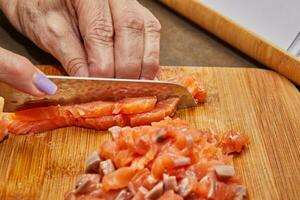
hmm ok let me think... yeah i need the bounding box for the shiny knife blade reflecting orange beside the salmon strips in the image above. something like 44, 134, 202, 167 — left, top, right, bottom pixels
0, 76, 196, 112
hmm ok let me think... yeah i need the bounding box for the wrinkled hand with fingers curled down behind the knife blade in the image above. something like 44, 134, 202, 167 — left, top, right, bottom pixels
0, 0, 161, 79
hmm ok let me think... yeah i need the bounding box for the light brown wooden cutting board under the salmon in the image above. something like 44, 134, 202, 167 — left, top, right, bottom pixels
0, 67, 300, 200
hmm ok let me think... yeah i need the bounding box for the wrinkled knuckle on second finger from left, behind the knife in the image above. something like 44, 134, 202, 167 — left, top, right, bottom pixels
83, 20, 114, 46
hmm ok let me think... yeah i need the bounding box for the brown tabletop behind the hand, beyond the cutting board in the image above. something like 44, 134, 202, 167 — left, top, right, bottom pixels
0, 0, 259, 67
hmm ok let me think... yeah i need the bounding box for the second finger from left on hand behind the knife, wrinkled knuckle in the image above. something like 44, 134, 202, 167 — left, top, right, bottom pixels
74, 0, 115, 78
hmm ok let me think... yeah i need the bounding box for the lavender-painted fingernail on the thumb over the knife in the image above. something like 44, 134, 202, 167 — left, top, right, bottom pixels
33, 72, 57, 95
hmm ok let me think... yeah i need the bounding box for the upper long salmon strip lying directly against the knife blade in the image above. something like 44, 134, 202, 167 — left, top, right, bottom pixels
15, 97, 157, 122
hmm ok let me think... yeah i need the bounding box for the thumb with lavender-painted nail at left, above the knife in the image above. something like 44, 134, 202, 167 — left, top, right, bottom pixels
0, 48, 57, 96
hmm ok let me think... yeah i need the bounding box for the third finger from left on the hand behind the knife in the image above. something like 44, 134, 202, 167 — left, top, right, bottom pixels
110, 0, 144, 79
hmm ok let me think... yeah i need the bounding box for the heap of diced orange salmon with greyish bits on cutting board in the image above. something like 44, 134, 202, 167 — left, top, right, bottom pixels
65, 118, 249, 200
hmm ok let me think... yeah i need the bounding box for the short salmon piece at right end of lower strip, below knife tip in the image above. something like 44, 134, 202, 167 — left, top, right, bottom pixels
128, 98, 179, 126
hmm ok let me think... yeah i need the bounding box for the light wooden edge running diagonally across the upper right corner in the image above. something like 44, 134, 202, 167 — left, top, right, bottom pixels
159, 0, 300, 85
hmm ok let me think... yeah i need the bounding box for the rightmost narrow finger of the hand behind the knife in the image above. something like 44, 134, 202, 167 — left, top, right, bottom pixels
140, 8, 161, 79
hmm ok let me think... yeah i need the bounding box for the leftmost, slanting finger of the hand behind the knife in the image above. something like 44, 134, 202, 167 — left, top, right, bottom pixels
40, 14, 89, 76
